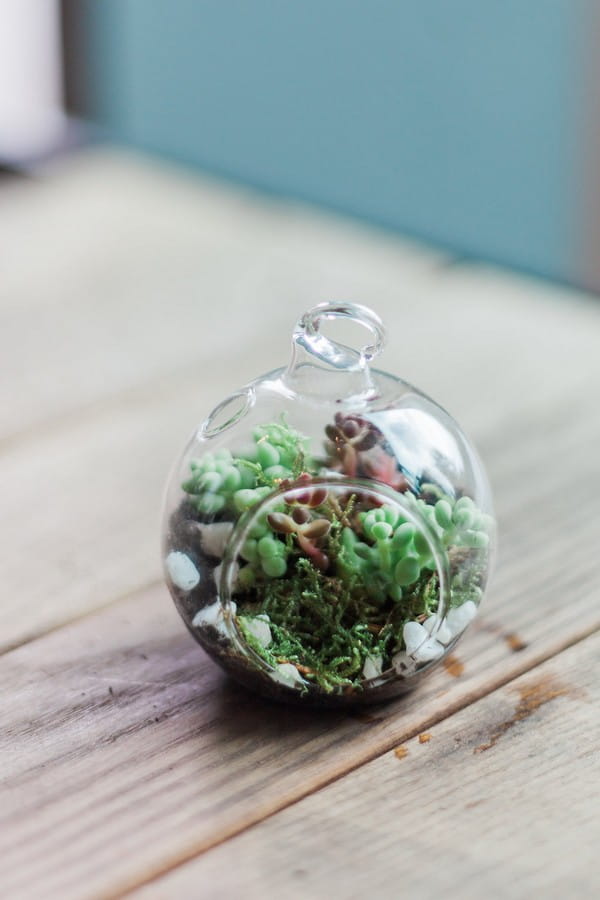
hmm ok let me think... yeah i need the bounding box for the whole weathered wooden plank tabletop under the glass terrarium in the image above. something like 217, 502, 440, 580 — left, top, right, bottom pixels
0, 151, 600, 900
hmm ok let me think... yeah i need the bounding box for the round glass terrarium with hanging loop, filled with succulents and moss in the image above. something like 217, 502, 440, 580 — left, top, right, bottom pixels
163, 303, 495, 705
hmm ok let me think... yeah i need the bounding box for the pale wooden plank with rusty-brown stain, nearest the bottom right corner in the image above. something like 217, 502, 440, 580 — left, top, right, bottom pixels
137, 636, 600, 900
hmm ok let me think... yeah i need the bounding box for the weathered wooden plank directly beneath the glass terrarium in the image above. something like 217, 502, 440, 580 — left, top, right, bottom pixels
0, 418, 600, 898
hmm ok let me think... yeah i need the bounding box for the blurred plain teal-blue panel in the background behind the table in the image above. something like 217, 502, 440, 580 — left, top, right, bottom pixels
86, 0, 588, 280
